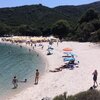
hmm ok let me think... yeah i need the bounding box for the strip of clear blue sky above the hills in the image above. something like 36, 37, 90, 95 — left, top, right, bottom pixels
0, 0, 100, 8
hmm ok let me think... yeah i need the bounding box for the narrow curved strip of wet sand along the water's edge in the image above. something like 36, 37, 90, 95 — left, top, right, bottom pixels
0, 41, 48, 100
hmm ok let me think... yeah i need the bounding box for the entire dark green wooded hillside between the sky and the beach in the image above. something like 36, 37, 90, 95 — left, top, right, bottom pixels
0, 2, 100, 41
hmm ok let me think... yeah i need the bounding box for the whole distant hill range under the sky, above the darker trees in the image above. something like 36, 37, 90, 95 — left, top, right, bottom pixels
0, 2, 100, 26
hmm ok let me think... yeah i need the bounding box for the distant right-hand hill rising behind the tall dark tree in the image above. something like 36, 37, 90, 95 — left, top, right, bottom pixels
54, 1, 100, 24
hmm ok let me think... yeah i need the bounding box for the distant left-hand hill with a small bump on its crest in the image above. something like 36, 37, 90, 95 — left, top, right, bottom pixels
0, 4, 66, 27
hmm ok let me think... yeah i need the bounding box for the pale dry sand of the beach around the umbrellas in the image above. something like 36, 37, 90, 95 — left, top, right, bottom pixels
2, 42, 100, 100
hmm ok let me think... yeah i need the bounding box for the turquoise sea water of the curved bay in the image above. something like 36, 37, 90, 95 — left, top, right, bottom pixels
0, 44, 45, 98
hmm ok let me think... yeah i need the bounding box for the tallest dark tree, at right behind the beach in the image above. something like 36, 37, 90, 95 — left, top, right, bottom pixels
76, 9, 100, 42
